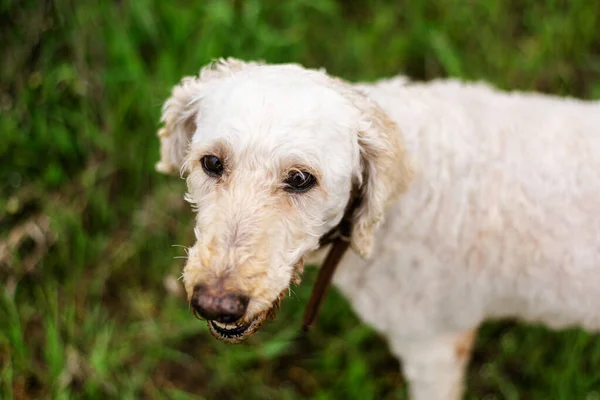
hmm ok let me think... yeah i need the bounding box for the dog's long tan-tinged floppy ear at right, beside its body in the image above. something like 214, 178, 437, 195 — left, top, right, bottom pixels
351, 95, 413, 258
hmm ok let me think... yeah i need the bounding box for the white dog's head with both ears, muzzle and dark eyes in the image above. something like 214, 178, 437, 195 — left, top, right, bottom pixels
157, 59, 410, 342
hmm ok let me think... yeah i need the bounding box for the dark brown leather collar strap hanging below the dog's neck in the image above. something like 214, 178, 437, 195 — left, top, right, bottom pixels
302, 187, 361, 331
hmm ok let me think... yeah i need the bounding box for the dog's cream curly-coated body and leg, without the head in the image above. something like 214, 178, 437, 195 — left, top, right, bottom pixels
328, 77, 600, 399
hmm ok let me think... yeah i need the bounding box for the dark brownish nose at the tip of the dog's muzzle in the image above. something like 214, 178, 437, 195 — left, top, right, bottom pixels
191, 285, 249, 323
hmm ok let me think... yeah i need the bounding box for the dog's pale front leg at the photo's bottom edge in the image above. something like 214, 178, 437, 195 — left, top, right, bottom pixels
390, 329, 476, 400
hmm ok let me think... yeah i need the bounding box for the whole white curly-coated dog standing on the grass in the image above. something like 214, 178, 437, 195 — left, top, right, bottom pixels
157, 59, 600, 399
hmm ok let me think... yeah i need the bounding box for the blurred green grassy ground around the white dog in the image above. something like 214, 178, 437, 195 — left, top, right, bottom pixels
0, 0, 600, 400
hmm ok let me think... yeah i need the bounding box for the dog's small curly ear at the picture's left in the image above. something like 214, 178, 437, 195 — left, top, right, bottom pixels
156, 58, 261, 175
